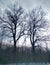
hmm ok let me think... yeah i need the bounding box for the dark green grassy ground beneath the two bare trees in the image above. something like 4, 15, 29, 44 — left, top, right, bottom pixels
0, 47, 50, 64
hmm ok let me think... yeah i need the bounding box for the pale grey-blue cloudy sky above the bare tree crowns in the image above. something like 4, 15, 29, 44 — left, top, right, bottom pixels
0, 0, 50, 20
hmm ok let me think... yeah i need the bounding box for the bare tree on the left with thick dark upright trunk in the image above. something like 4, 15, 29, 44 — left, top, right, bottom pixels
0, 4, 25, 49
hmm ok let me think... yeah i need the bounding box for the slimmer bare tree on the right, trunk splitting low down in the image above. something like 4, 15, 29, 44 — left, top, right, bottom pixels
28, 7, 46, 51
